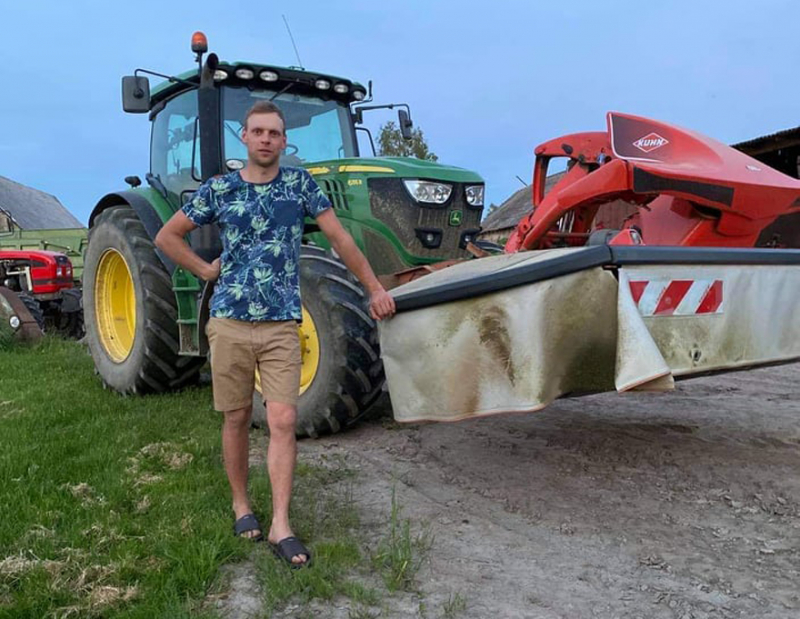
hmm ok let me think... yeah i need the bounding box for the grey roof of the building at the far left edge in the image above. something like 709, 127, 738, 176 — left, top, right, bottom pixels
0, 176, 84, 230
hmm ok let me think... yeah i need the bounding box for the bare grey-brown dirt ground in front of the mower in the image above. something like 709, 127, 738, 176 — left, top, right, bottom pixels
220, 364, 800, 619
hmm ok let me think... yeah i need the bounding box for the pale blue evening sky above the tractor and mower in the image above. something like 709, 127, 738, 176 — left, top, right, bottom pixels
0, 0, 800, 222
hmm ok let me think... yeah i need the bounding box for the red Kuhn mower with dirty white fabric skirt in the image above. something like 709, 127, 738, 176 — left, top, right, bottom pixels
381, 112, 800, 421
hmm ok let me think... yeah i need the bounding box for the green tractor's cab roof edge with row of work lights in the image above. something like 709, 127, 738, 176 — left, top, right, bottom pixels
151, 61, 366, 106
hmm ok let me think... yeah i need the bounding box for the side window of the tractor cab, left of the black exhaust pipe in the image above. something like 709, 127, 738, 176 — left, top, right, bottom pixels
150, 90, 200, 203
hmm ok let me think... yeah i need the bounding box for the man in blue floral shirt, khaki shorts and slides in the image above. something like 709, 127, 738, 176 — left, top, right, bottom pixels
156, 101, 395, 567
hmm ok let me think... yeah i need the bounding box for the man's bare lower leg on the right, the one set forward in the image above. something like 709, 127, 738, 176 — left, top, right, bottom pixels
267, 402, 308, 563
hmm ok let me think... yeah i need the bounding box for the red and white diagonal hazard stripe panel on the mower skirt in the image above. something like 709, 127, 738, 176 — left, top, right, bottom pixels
630, 279, 723, 316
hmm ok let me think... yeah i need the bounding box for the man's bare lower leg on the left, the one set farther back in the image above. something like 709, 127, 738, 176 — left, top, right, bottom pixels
222, 406, 262, 537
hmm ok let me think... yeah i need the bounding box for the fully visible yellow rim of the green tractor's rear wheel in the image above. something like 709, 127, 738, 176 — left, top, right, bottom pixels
94, 249, 136, 363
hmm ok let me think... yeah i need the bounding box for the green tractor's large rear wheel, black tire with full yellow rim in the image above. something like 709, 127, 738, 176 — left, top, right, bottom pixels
83, 204, 205, 394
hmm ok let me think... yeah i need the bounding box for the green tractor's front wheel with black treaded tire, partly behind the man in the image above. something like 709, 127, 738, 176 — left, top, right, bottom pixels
253, 245, 385, 438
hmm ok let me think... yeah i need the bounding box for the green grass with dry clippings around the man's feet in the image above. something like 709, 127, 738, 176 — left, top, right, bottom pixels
0, 338, 418, 619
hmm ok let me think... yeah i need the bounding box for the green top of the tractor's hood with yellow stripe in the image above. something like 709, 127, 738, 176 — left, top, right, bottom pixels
305, 157, 483, 183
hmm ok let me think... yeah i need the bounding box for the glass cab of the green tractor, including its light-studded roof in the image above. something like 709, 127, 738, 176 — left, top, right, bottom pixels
142, 63, 366, 206
